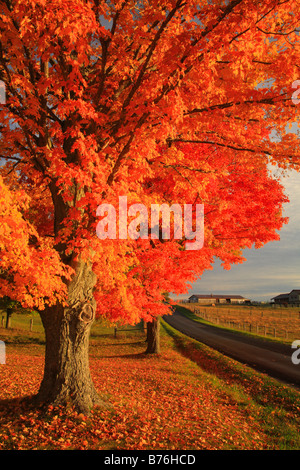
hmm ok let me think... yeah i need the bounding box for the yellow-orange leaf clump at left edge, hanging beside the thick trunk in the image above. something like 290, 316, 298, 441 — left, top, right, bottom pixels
0, 176, 72, 309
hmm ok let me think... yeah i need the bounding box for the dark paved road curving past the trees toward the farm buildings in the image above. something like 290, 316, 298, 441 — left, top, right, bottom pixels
164, 310, 300, 388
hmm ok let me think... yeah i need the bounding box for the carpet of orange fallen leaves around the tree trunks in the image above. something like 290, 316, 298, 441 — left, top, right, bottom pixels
0, 326, 299, 450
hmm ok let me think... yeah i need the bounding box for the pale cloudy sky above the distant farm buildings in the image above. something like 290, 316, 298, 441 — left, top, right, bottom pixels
171, 125, 300, 302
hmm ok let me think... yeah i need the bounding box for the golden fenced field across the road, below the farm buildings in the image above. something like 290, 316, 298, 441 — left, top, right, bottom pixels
184, 303, 300, 342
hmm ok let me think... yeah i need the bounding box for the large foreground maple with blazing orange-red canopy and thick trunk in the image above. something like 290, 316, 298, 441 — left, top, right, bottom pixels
0, 0, 300, 411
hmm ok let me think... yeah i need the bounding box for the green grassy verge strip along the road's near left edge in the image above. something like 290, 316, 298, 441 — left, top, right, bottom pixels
164, 323, 300, 450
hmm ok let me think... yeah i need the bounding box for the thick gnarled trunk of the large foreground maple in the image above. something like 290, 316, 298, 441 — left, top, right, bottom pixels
36, 261, 106, 414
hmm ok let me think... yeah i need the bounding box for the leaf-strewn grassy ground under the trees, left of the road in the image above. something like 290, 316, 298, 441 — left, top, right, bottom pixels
0, 318, 300, 450
